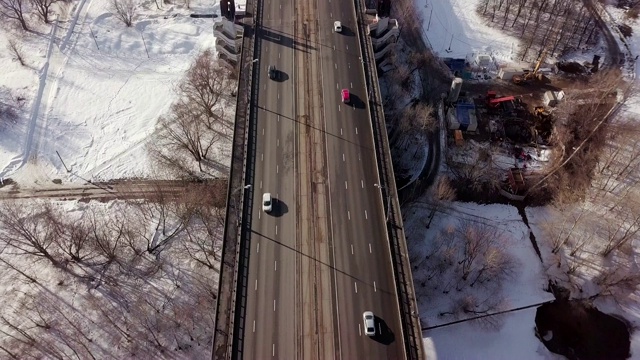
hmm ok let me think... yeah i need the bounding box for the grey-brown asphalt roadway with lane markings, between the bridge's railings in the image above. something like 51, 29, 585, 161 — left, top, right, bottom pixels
242, 0, 405, 359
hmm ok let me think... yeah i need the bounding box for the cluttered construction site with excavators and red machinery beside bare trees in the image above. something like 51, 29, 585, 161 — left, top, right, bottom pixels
441, 50, 622, 200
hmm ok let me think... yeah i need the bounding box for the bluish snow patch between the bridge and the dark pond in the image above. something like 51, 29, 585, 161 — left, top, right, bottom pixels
405, 203, 555, 359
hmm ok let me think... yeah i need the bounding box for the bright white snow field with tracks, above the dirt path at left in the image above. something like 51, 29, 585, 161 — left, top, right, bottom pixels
0, 0, 225, 186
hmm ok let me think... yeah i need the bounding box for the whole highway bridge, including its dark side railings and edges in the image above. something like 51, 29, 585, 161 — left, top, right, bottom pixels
213, 0, 423, 359
